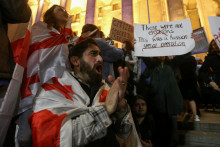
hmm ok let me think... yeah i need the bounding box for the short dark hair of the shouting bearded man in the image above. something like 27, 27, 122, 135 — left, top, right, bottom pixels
69, 38, 98, 68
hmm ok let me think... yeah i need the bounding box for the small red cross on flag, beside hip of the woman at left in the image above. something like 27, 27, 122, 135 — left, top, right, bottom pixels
21, 69, 40, 99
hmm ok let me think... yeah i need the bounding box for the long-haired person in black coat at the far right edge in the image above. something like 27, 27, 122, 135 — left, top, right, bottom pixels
199, 40, 220, 108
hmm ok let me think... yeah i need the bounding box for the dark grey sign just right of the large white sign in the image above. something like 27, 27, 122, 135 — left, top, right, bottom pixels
192, 27, 209, 54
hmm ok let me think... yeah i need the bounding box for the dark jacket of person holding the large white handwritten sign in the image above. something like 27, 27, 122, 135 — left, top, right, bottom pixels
144, 58, 183, 115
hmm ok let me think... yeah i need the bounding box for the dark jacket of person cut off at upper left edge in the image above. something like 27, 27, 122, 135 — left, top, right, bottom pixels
0, 0, 31, 80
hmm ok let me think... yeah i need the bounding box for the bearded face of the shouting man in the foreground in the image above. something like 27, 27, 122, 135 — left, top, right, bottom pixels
80, 45, 103, 84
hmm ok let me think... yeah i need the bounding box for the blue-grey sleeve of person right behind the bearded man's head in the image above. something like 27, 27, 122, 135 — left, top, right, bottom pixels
96, 38, 124, 62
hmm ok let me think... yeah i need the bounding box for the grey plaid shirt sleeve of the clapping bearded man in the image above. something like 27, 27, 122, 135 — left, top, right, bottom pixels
72, 106, 112, 146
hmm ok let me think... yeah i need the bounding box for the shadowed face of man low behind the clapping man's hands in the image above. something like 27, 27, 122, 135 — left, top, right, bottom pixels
133, 99, 147, 117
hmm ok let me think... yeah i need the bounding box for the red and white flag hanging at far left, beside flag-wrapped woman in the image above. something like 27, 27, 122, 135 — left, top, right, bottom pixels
0, 17, 32, 146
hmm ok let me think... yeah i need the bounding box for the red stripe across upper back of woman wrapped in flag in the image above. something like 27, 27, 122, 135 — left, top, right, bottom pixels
28, 32, 67, 57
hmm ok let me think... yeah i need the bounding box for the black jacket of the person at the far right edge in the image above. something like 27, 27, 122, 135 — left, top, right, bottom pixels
199, 53, 220, 86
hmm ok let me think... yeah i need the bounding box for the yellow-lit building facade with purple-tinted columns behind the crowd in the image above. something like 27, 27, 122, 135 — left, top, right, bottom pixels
29, 0, 220, 57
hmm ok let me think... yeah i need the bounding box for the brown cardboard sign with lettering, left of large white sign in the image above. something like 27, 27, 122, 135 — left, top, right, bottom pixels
109, 18, 134, 42
